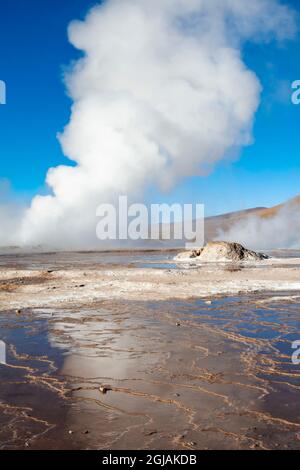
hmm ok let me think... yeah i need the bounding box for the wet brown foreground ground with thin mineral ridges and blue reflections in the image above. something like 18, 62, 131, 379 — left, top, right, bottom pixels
0, 266, 300, 449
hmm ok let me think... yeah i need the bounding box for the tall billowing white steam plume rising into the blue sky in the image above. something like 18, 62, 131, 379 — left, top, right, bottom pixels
0, 0, 295, 247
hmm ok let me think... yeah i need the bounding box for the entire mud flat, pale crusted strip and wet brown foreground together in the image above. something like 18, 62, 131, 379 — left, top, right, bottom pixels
0, 254, 300, 449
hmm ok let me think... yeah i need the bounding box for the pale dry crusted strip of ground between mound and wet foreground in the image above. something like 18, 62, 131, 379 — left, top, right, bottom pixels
0, 253, 300, 309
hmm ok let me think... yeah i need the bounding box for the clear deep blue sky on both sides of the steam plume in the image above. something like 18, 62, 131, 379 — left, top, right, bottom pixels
0, 0, 300, 214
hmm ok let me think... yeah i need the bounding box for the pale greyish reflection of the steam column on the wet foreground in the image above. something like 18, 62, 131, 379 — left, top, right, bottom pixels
44, 306, 184, 448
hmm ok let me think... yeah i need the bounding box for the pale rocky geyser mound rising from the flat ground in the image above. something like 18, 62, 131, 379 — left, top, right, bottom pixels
175, 241, 268, 262
